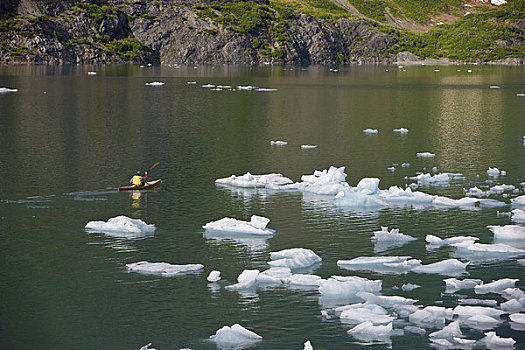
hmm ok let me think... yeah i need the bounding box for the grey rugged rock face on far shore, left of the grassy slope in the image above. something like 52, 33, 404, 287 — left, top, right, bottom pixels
0, 0, 396, 65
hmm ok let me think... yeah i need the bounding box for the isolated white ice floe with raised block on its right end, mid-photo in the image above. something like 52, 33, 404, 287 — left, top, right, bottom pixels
202, 215, 275, 236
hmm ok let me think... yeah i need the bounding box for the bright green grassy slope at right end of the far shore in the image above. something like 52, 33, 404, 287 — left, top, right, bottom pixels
380, 0, 525, 61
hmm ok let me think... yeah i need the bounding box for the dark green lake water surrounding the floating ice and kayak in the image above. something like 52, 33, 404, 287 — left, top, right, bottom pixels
0, 66, 525, 350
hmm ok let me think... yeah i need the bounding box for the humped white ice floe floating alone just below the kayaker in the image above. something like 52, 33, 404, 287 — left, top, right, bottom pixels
85, 215, 155, 238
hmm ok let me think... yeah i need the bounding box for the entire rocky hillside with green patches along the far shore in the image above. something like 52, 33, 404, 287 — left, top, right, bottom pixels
0, 0, 525, 65
